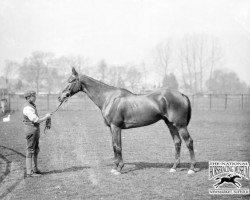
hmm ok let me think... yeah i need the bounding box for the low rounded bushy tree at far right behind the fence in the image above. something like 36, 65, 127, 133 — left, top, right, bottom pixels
206, 70, 247, 94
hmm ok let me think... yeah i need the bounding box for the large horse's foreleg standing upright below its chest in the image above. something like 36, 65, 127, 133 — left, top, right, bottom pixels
111, 124, 124, 174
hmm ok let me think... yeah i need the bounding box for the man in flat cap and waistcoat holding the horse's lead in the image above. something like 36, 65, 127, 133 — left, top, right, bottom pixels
23, 90, 51, 177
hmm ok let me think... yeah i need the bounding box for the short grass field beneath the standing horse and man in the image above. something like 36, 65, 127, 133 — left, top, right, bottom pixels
0, 110, 250, 199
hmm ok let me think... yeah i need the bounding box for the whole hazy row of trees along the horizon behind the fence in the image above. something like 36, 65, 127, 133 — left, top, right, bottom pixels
0, 34, 250, 94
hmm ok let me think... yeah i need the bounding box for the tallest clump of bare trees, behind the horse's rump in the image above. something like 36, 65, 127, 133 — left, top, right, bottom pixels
179, 34, 222, 93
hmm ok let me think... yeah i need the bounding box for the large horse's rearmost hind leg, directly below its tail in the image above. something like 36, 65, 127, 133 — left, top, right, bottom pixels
178, 127, 196, 174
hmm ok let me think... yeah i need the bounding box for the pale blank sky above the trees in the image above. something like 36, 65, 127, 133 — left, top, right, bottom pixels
0, 0, 250, 85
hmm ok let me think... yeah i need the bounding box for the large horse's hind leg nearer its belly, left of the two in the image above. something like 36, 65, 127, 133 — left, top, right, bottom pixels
164, 119, 181, 172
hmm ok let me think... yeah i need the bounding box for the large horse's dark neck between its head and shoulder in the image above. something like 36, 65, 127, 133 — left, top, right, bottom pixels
82, 76, 114, 109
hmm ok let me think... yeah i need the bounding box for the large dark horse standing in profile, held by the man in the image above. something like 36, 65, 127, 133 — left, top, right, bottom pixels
58, 68, 195, 175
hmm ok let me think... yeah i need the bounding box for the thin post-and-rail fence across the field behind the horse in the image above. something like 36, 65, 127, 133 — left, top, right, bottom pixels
2, 93, 250, 111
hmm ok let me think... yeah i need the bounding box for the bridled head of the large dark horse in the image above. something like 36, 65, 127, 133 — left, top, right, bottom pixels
58, 67, 82, 102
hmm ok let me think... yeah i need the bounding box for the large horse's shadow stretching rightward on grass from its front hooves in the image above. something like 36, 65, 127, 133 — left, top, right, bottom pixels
123, 162, 208, 174
